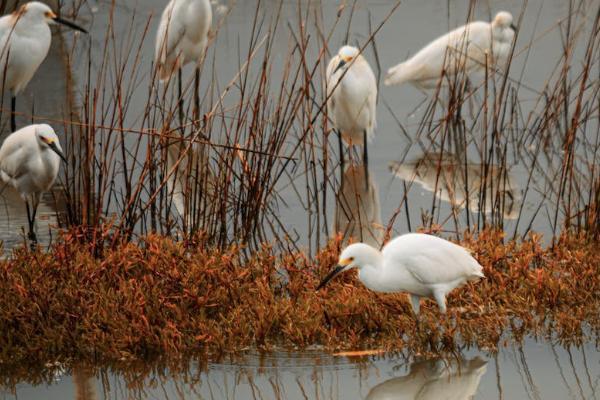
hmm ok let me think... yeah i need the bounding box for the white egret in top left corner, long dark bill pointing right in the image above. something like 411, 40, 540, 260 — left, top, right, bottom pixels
0, 1, 87, 132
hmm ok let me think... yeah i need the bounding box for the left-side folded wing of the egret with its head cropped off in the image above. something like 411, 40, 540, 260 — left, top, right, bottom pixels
155, 0, 185, 79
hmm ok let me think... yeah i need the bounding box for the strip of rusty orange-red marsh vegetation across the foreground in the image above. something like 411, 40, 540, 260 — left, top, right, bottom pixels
0, 231, 600, 366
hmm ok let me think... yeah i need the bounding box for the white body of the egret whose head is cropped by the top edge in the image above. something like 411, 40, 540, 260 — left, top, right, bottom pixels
155, 0, 212, 80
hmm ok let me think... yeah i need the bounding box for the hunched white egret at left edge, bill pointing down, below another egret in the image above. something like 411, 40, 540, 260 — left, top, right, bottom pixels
0, 124, 67, 242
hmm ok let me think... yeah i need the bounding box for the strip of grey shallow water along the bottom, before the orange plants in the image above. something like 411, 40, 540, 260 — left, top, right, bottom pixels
0, 341, 600, 400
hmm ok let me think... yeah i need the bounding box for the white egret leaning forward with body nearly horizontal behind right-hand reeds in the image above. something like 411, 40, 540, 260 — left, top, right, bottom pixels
384, 11, 516, 89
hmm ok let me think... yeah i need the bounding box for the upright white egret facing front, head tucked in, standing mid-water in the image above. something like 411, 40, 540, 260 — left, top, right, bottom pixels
326, 46, 377, 171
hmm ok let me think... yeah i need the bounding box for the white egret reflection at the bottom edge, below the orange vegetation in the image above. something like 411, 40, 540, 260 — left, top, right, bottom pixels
367, 357, 487, 400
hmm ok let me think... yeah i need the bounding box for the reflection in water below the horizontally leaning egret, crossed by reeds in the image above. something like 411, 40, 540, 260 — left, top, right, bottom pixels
390, 153, 522, 219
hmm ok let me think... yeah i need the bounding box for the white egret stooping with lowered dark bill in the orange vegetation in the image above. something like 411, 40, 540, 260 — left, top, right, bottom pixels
317, 233, 484, 315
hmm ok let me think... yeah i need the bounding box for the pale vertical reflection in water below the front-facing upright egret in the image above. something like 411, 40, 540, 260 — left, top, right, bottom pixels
333, 165, 384, 247
